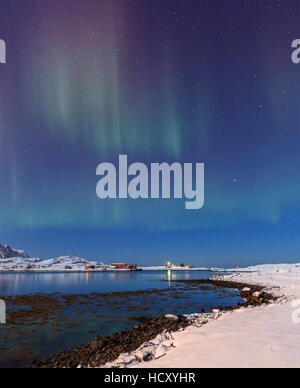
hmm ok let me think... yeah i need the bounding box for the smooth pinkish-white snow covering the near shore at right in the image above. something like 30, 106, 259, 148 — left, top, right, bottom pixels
133, 264, 300, 368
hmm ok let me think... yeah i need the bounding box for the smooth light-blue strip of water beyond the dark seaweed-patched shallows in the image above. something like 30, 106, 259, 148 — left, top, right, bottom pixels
0, 271, 204, 296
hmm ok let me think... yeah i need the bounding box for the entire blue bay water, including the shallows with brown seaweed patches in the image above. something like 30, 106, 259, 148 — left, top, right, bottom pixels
0, 271, 242, 367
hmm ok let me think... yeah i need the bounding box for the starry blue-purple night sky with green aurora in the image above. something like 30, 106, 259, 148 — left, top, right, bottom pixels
0, 0, 300, 266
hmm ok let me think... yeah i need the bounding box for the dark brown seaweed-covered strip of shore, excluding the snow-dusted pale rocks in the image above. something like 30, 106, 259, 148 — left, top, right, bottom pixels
33, 280, 277, 368
